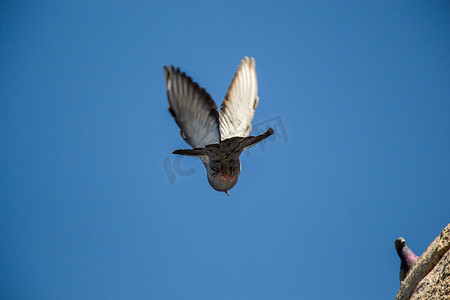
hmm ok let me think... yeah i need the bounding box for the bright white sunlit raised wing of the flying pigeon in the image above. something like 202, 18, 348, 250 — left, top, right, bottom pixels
219, 57, 259, 140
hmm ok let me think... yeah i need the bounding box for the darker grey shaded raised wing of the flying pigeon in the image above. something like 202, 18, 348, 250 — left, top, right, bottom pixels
164, 66, 220, 148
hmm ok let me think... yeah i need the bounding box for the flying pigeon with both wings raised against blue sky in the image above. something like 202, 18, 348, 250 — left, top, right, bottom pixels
164, 57, 273, 195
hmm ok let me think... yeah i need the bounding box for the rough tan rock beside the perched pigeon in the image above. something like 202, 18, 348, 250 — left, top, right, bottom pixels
395, 224, 450, 300
